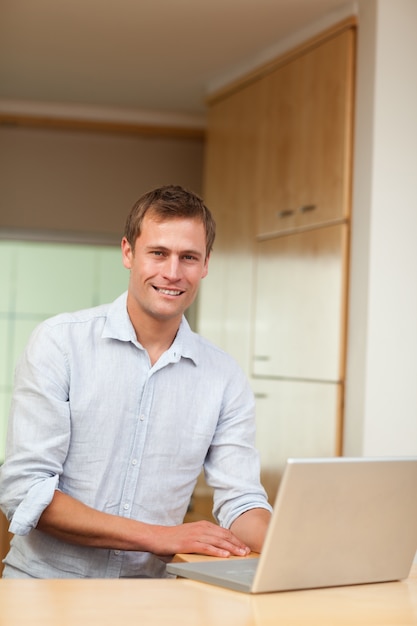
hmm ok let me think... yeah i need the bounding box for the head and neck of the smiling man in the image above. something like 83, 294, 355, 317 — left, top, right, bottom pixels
122, 192, 210, 363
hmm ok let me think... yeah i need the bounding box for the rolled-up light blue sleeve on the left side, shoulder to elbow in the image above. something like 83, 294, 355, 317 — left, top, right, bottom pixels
0, 324, 70, 535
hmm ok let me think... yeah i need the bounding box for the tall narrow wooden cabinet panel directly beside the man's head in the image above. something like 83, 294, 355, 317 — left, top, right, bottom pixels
197, 80, 260, 373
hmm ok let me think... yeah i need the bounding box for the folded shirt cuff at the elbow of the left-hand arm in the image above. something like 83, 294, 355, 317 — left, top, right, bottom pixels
9, 475, 59, 535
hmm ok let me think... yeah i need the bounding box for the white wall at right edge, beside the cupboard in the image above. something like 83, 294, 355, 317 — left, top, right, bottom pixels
344, 0, 417, 455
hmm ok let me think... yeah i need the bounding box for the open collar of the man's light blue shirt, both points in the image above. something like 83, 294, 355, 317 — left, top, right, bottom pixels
102, 291, 199, 365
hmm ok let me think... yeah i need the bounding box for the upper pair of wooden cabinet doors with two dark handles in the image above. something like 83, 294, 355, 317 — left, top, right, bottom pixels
256, 29, 355, 235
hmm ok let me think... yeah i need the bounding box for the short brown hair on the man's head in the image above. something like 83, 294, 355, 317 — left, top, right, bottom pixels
124, 185, 216, 257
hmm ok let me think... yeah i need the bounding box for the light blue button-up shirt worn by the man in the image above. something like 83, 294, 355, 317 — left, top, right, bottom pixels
0, 294, 271, 578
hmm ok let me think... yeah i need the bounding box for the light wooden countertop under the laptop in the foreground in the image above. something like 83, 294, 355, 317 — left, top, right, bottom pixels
0, 565, 417, 626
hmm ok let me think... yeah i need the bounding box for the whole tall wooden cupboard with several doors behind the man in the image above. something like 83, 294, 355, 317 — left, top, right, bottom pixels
197, 18, 355, 500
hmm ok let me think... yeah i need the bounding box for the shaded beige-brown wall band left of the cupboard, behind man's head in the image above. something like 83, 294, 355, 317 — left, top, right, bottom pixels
0, 126, 204, 242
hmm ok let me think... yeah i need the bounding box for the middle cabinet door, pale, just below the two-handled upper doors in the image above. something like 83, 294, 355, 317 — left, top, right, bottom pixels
253, 224, 348, 382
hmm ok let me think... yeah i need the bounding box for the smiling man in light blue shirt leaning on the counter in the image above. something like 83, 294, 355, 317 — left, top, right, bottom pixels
0, 186, 271, 578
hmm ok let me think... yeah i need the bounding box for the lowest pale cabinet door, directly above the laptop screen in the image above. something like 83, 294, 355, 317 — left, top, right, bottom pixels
252, 379, 342, 500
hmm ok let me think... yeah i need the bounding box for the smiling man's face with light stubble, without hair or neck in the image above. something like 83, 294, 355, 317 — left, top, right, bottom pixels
122, 214, 208, 321
